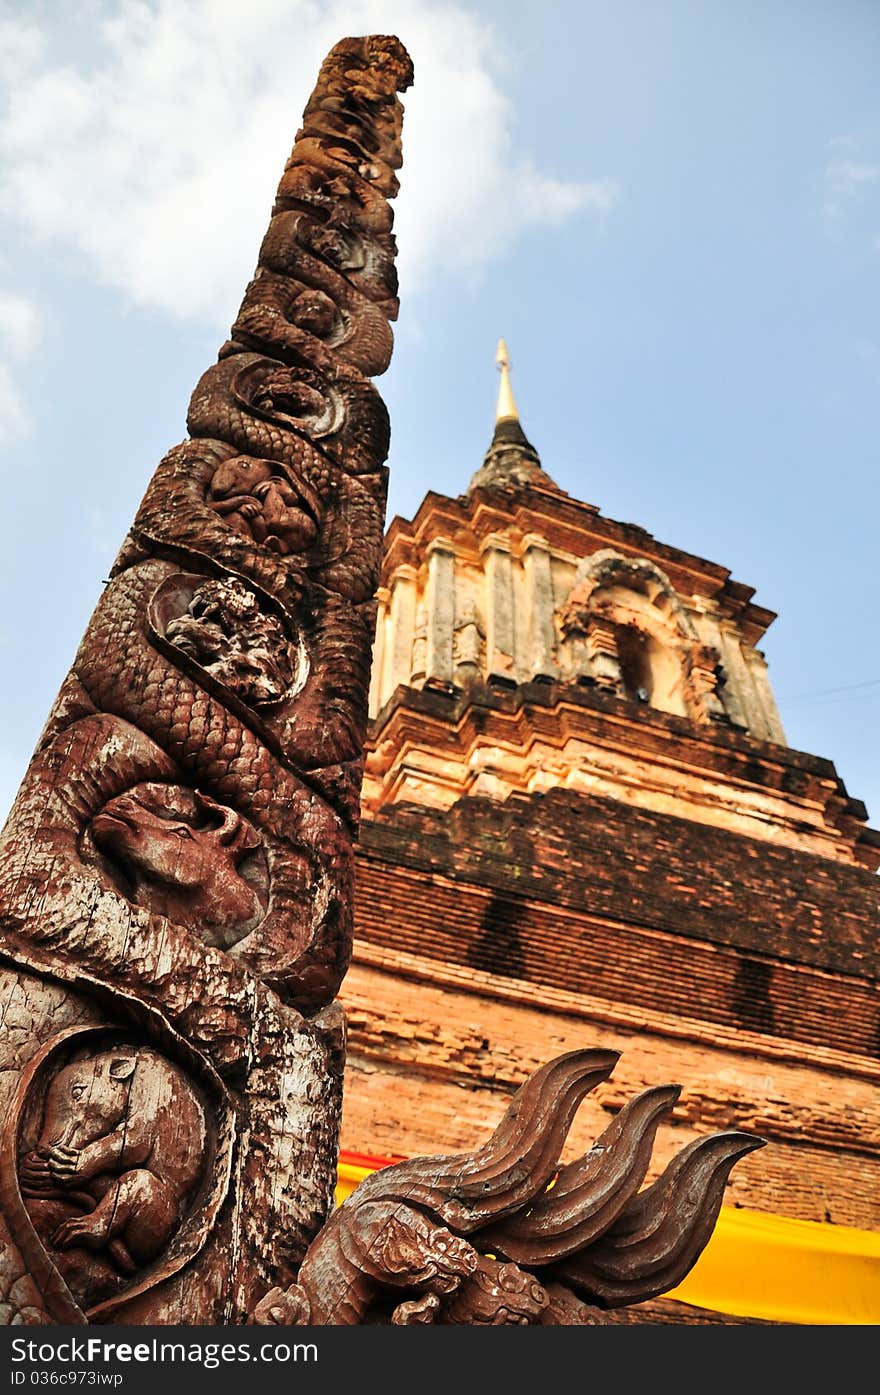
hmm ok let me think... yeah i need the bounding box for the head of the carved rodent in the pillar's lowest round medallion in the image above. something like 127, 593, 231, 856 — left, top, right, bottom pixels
39, 1050, 137, 1148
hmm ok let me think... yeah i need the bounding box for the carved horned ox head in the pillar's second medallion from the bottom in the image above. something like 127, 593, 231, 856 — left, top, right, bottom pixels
92, 784, 265, 947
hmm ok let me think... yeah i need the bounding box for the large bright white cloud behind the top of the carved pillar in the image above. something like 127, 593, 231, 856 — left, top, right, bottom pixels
0, 0, 618, 326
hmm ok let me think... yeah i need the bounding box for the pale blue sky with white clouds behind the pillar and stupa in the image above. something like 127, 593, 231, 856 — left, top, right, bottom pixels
0, 0, 880, 823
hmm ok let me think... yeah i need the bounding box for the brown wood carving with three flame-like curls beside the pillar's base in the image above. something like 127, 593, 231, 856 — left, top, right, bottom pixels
252, 1050, 763, 1327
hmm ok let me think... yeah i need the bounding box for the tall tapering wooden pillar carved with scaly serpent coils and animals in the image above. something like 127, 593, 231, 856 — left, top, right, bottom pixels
0, 36, 411, 1324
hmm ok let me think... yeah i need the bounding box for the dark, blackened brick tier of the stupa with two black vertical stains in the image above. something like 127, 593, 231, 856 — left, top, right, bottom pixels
356, 790, 880, 1056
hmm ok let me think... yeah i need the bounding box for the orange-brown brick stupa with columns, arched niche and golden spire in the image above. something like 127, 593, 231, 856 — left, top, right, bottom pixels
342, 343, 880, 1322
